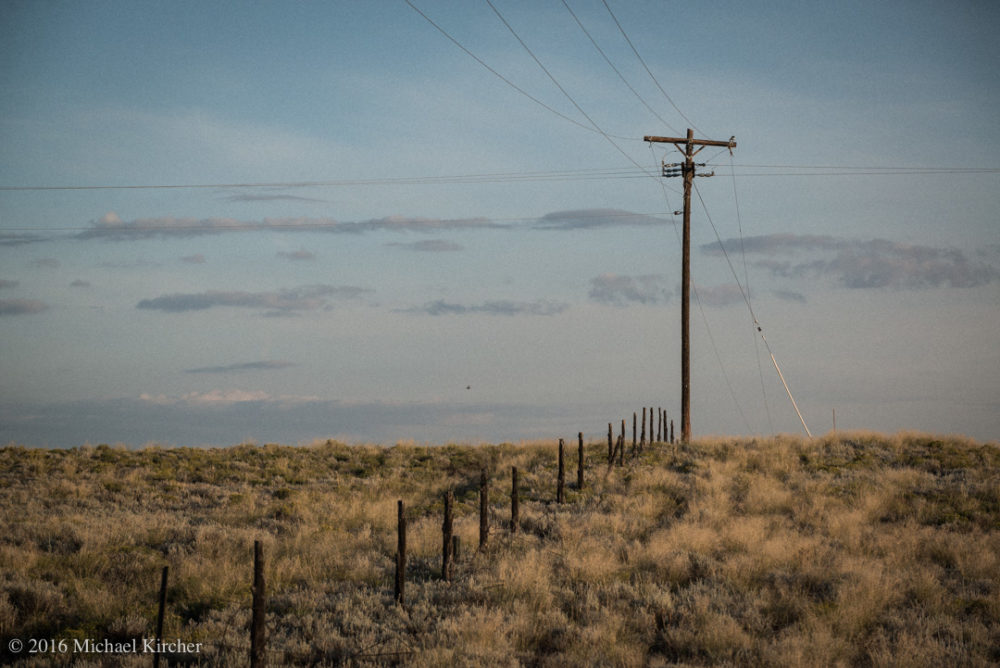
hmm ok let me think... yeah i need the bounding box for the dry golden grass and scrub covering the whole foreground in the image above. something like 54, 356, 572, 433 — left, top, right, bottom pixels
0, 433, 1000, 666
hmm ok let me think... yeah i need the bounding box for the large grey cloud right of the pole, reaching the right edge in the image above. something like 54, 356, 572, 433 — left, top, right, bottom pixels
701, 234, 1000, 289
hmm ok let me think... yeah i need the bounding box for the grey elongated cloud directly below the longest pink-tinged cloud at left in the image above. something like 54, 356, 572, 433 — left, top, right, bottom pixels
136, 285, 374, 314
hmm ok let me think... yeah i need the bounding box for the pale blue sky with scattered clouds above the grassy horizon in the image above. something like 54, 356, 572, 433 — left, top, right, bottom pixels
0, 0, 1000, 447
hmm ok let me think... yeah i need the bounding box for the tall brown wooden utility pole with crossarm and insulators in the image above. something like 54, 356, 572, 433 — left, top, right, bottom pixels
643, 128, 736, 443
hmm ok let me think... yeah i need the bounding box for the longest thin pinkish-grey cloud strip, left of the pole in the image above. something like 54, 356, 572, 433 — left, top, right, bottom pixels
74, 212, 507, 241
